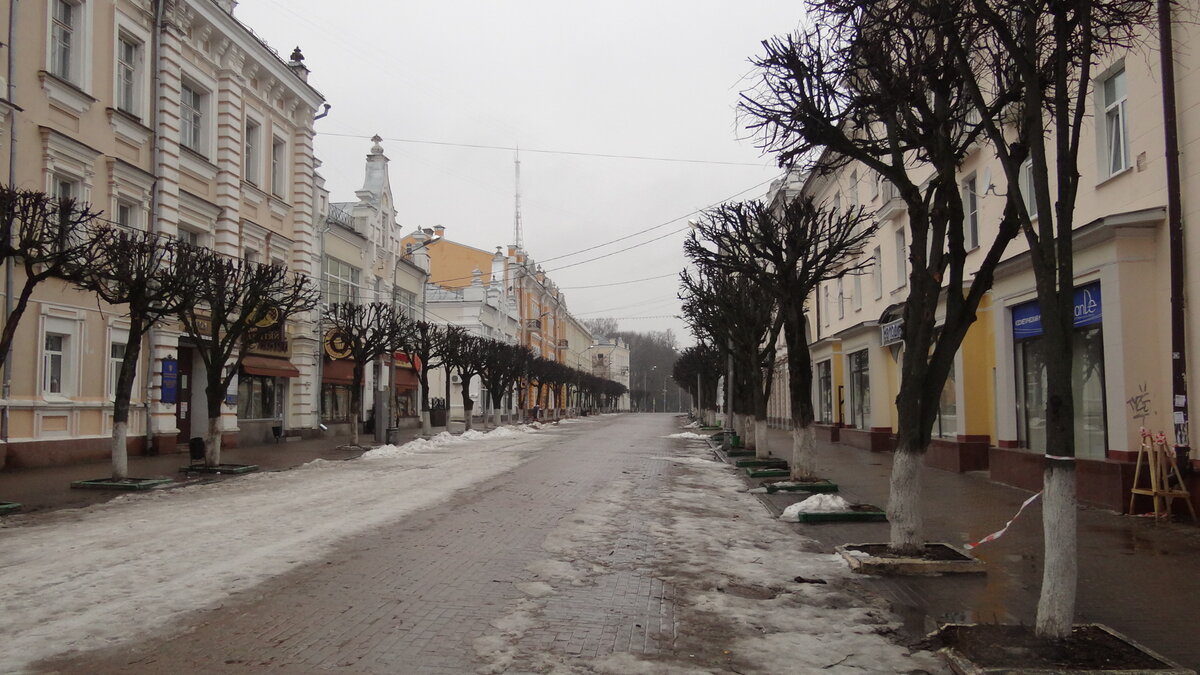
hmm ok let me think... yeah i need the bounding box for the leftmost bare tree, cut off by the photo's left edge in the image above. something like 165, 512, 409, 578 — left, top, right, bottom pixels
0, 186, 98, 369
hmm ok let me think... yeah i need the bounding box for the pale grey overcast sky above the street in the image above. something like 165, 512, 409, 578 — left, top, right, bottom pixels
235, 0, 802, 345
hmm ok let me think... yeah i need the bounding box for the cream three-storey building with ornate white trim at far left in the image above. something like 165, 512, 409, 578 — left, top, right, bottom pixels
0, 0, 323, 466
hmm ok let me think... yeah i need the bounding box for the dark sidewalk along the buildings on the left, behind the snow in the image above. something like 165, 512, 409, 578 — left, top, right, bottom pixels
0, 423, 439, 513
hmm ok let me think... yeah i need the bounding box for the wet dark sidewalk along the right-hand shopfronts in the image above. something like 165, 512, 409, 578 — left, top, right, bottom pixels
750, 429, 1200, 668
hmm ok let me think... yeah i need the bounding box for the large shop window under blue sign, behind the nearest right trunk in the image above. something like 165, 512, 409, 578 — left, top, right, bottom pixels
1013, 283, 1108, 459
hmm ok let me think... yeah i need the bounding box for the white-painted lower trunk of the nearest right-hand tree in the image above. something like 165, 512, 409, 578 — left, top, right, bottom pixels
1037, 461, 1079, 638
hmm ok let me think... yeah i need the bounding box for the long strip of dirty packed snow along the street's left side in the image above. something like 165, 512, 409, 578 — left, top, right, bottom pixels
0, 428, 548, 673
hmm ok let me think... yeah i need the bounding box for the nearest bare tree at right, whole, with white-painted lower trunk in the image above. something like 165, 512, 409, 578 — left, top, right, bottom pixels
953, 0, 1156, 638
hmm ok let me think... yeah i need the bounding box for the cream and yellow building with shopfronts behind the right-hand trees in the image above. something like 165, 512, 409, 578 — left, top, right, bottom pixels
769, 12, 1200, 510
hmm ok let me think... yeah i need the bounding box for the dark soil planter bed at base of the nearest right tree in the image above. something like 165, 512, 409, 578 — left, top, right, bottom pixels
925, 623, 1195, 675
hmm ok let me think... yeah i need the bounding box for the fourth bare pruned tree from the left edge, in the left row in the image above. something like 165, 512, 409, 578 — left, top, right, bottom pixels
324, 303, 413, 446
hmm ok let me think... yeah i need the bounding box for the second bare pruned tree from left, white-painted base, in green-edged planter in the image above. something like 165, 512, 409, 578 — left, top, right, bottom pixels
76, 227, 200, 479
